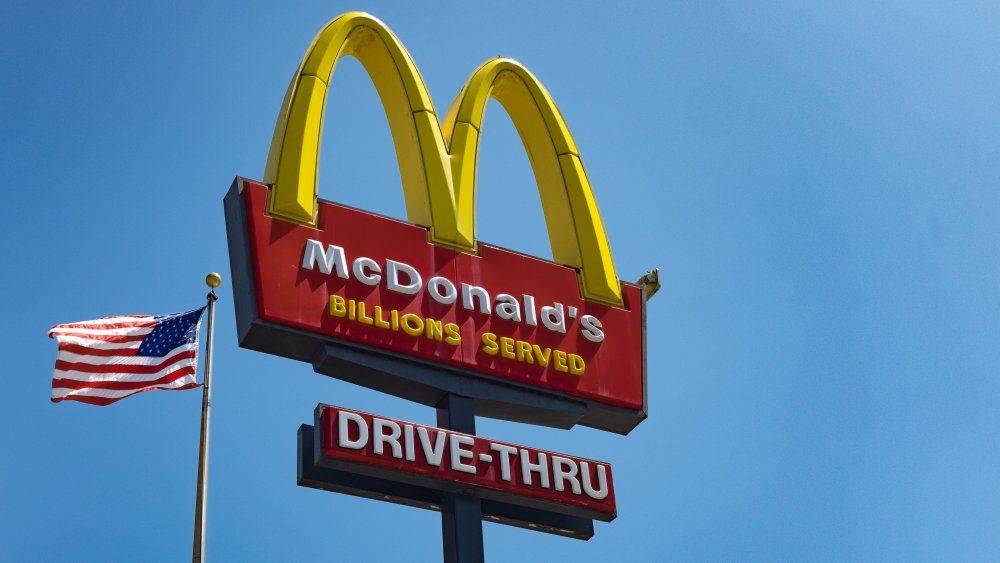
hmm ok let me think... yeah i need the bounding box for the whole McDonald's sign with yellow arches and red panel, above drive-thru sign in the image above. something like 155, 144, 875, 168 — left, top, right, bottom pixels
225, 13, 647, 433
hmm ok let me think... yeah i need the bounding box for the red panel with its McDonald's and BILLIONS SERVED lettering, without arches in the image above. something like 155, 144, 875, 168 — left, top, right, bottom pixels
241, 180, 644, 411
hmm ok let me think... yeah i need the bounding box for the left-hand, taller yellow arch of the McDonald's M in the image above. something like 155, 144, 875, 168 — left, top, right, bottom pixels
264, 12, 466, 248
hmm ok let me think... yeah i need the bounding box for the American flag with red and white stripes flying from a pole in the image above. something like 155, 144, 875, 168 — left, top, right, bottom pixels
49, 307, 205, 405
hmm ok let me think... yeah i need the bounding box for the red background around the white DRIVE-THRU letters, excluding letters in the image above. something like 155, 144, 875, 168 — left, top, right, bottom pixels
317, 405, 617, 521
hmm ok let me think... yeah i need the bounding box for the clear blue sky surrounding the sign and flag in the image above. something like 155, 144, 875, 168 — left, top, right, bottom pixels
0, 1, 1000, 561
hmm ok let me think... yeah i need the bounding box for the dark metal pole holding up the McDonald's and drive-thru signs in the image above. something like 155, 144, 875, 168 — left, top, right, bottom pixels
437, 393, 485, 563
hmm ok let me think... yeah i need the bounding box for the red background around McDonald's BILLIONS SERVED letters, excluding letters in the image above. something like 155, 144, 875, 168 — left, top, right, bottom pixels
242, 181, 643, 410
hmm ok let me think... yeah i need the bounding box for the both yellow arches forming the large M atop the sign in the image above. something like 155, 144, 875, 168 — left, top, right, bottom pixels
264, 12, 622, 306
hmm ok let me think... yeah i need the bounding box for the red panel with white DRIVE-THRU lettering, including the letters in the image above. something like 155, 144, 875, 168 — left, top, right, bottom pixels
316, 405, 616, 522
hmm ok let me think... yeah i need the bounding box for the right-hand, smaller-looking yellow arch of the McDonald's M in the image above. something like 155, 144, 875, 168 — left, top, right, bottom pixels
444, 57, 622, 305
